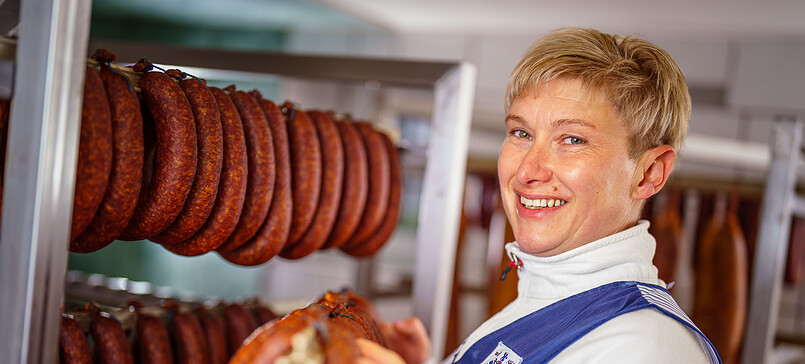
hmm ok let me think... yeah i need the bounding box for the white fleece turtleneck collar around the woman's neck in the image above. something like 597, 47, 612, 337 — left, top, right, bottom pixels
506, 220, 665, 300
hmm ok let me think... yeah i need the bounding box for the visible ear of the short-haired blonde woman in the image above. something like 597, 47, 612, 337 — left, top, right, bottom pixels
632, 145, 676, 200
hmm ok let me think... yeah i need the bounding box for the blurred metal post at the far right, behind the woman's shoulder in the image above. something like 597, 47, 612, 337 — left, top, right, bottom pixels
741, 117, 803, 364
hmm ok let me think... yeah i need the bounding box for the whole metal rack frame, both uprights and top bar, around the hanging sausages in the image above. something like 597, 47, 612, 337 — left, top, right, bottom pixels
0, 0, 476, 363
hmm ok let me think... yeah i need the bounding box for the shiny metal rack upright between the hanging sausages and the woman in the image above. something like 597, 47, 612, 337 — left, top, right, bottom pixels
414, 63, 476, 363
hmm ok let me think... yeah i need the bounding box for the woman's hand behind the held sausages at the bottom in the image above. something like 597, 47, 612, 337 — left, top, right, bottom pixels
358, 317, 430, 364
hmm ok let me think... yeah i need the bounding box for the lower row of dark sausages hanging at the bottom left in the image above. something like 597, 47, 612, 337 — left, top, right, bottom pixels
59, 302, 277, 364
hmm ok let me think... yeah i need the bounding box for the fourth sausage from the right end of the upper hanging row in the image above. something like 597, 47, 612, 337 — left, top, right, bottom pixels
280, 110, 344, 259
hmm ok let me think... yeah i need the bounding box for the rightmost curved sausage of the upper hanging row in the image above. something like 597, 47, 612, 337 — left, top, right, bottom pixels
344, 133, 402, 257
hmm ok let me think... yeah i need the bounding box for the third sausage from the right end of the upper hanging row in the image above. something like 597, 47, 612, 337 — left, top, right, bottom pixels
323, 121, 369, 249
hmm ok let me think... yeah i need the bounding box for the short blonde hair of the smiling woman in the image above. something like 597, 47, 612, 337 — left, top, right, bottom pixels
506, 28, 691, 158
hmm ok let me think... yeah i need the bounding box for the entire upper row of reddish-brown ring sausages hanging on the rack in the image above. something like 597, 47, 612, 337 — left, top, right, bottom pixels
70, 51, 402, 265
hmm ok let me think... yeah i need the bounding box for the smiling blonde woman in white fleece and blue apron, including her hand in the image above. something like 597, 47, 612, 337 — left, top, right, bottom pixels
361, 28, 720, 363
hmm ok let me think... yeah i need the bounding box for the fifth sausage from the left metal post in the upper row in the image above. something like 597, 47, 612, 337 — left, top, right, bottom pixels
166, 87, 249, 252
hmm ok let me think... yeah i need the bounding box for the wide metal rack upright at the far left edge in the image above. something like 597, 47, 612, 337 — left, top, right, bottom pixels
0, 0, 92, 363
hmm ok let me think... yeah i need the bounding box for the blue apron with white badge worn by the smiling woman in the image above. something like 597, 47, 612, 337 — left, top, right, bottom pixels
452, 282, 721, 364
